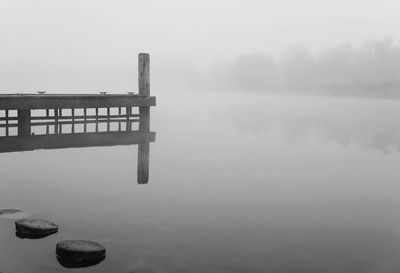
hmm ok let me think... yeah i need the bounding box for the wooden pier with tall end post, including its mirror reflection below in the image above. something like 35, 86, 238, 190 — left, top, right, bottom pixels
0, 53, 156, 184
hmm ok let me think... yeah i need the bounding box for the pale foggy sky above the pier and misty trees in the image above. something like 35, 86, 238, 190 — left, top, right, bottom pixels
0, 0, 400, 92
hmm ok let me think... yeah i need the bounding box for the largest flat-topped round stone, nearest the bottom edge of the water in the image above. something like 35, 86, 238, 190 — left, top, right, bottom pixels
56, 240, 106, 262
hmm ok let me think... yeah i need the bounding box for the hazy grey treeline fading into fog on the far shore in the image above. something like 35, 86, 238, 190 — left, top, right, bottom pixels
177, 39, 400, 97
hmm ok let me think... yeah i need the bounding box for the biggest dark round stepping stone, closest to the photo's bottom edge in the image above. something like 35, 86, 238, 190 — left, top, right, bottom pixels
56, 240, 106, 268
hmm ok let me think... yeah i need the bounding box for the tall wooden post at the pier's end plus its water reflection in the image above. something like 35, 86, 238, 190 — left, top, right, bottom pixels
137, 53, 150, 184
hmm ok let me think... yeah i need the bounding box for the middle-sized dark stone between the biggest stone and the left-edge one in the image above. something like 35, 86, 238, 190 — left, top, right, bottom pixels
15, 219, 58, 239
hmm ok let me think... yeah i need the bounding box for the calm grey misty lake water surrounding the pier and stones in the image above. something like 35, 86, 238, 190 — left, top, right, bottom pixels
0, 92, 400, 273
